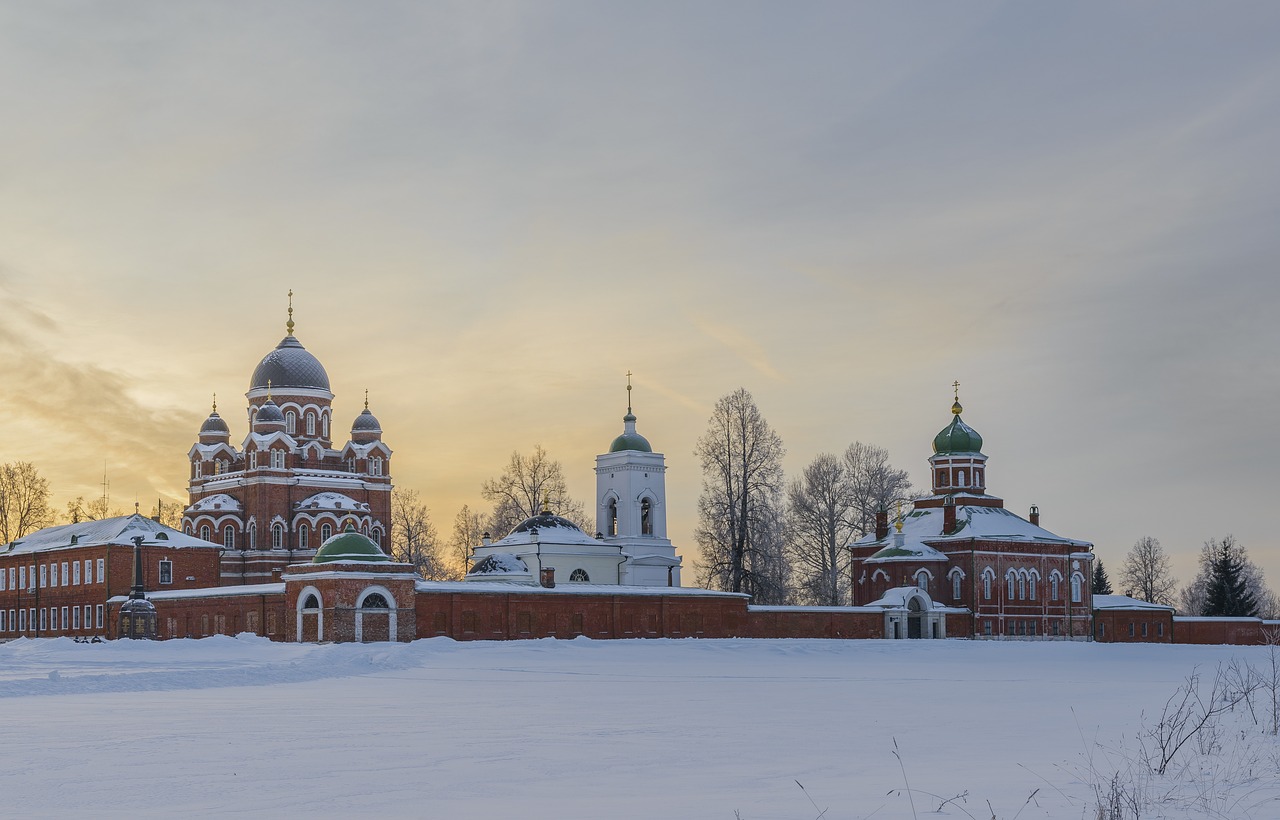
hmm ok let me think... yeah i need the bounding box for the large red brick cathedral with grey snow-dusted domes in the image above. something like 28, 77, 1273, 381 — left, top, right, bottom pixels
182, 304, 392, 585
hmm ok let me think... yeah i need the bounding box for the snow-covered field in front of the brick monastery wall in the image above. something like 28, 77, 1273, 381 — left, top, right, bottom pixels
0, 637, 1280, 820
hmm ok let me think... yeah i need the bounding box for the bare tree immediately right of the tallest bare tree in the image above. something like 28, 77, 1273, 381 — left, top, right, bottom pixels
787, 453, 858, 606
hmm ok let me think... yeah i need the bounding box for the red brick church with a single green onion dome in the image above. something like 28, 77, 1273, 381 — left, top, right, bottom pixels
852, 395, 1093, 637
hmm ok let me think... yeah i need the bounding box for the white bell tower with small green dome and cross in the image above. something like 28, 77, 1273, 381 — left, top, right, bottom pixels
595, 372, 680, 586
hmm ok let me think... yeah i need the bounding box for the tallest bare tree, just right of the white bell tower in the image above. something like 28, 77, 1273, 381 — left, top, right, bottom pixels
694, 388, 786, 600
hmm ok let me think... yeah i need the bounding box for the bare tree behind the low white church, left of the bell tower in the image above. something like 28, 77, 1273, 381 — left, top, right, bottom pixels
480, 444, 595, 537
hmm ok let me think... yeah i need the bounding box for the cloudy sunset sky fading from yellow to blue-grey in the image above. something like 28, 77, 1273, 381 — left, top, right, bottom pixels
0, 0, 1280, 587
